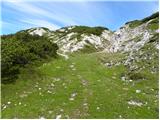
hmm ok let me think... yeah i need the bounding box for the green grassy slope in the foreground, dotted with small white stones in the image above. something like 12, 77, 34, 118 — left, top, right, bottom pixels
2, 54, 158, 118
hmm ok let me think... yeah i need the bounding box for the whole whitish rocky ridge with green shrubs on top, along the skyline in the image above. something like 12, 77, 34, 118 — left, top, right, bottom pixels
25, 13, 159, 54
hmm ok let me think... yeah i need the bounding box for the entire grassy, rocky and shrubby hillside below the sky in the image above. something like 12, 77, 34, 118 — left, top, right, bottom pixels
1, 13, 159, 119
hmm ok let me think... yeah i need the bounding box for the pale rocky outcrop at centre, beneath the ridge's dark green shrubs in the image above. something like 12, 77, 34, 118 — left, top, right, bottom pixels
49, 27, 112, 54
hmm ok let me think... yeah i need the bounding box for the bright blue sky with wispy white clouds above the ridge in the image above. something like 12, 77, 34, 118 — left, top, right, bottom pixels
0, 0, 158, 34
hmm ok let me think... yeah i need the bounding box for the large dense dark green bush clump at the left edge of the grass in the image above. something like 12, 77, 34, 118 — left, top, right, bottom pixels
1, 32, 58, 83
